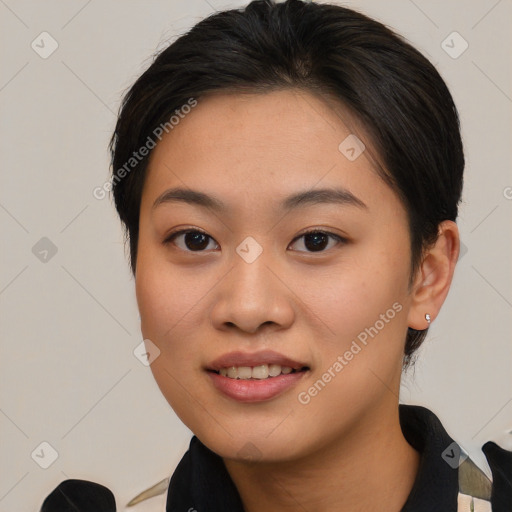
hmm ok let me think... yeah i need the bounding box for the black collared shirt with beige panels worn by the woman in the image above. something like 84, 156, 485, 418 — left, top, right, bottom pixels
41, 405, 512, 512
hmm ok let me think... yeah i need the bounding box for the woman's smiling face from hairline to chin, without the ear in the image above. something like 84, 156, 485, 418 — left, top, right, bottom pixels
136, 91, 418, 461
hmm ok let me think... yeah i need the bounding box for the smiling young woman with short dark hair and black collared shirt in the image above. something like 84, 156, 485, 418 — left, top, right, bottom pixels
41, 0, 511, 512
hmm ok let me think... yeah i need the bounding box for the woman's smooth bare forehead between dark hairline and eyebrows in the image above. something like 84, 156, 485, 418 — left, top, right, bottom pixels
143, 90, 391, 215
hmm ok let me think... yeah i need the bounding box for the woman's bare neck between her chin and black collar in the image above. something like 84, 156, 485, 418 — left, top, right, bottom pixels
224, 407, 420, 512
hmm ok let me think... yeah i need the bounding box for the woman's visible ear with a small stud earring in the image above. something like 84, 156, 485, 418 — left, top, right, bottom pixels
408, 220, 460, 331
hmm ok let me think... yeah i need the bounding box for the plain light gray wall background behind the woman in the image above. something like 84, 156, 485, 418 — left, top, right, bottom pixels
0, 0, 512, 512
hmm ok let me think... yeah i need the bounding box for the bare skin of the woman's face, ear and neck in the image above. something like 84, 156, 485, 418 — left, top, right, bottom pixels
136, 90, 459, 512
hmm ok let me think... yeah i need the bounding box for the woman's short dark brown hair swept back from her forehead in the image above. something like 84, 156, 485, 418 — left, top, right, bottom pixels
110, 0, 464, 364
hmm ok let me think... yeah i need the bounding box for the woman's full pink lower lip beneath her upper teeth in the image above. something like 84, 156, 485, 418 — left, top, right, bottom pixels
208, 371, 308, 402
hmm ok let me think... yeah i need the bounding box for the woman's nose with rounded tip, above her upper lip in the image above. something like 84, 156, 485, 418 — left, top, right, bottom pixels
211, 251, 295, 334
